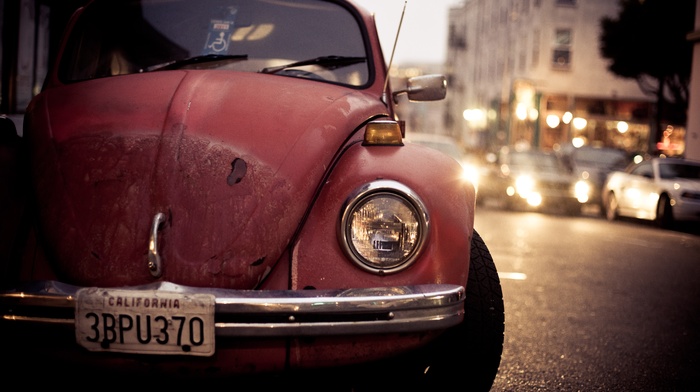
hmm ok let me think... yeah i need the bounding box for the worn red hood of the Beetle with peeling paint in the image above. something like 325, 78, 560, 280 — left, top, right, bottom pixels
26, 71, 386, 288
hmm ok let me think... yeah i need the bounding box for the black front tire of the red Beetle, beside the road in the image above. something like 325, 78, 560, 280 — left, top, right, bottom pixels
351, 231, 505, 392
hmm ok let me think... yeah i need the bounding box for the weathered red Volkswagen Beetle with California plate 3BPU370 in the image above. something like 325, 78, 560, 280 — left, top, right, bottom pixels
0, 0, 504, 390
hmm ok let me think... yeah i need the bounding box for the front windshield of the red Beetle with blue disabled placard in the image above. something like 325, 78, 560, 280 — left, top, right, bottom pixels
59, 0, 369, 86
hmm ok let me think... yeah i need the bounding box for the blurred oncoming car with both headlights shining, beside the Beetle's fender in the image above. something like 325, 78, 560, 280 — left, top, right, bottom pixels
479, 148, 589, 215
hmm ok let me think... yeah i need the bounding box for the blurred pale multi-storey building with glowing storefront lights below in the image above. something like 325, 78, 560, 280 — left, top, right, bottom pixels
444, 0, 655, 156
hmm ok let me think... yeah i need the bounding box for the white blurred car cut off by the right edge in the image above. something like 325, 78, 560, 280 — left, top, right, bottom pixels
604, 157, 700, 228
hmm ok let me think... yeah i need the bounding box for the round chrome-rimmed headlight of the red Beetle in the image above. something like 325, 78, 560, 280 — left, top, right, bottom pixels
338, 180, 429, 274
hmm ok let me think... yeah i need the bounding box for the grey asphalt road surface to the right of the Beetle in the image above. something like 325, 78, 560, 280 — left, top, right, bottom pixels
475, 207, 700, 392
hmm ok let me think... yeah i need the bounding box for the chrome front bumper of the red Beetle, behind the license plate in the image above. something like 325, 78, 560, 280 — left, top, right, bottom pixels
0, 281, 465, 337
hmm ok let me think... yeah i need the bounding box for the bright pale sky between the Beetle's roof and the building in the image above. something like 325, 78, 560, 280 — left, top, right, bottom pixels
355, 0, 463, 66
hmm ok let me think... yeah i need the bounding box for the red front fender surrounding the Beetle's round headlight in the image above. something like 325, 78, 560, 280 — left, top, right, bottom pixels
291, 142, 475, 289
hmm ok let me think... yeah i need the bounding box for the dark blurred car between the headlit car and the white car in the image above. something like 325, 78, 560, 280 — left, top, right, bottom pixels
562, 145, 632, 214
